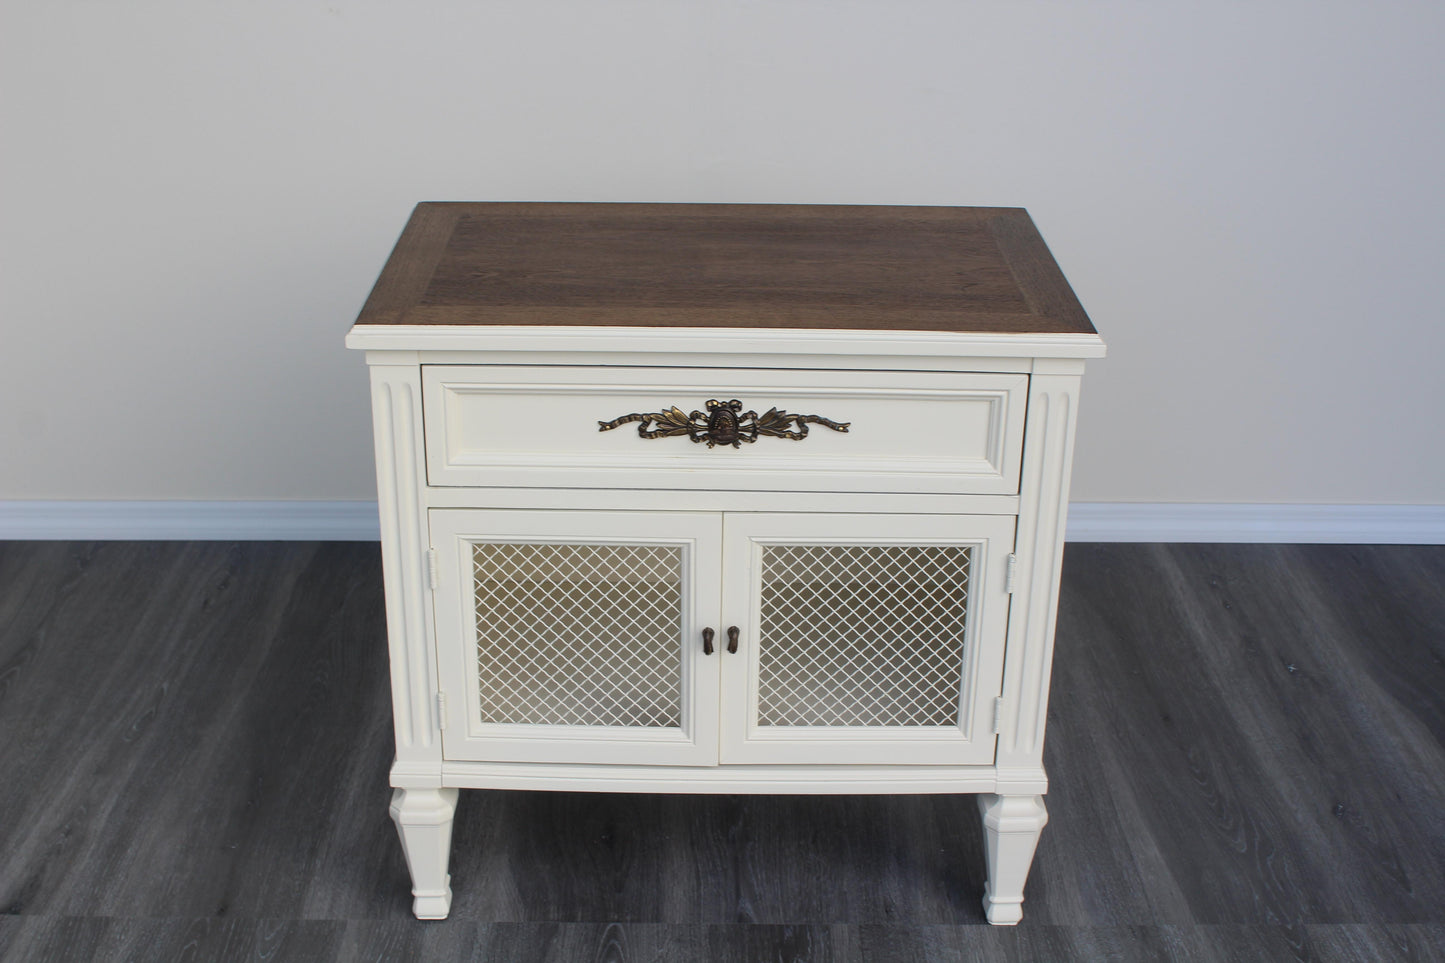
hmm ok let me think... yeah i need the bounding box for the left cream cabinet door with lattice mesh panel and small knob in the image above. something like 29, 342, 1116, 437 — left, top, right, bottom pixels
431, 510, 721, 765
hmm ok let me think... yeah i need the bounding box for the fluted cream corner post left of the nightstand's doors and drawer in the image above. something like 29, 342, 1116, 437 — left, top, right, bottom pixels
371, 364, 441, 762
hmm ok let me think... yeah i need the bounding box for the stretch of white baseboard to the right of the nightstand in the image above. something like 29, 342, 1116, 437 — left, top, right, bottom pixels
1066, 502, 1445, 545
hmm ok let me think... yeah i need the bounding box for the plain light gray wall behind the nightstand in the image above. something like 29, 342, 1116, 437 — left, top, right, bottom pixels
0, 0, 1445, 503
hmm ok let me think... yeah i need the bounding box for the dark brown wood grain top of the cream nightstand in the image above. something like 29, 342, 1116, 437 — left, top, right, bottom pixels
357, 202, 1094, 334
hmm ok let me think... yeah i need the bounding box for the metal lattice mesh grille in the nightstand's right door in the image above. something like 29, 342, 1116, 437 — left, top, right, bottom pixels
757, 545, 968, 726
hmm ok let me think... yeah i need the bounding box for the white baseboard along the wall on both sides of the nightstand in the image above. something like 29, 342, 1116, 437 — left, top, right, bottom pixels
0, 502, 1445, 545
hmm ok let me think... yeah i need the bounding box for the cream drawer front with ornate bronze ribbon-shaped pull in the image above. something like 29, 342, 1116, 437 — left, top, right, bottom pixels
422, 364, 1029, 495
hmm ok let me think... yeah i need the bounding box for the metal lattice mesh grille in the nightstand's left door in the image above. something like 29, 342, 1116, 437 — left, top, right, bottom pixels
473, 542, 682, 727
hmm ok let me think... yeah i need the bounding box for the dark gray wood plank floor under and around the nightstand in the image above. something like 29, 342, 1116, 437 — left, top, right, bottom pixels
0, 542, 1445, 962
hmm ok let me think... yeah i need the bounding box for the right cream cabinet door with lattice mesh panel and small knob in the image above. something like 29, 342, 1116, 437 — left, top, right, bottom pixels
721, 513, 1014, 765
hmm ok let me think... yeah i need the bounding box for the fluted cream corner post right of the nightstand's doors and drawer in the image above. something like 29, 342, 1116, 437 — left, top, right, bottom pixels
997, 375, 1079, 769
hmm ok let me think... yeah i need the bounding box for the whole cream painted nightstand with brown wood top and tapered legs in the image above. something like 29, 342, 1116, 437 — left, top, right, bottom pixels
347, 204, 1104, 923
